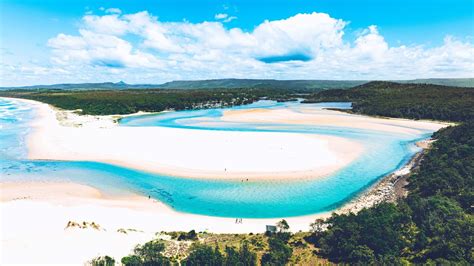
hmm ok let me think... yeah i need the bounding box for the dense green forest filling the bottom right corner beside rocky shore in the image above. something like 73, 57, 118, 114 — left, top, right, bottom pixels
315, 123, 474, 264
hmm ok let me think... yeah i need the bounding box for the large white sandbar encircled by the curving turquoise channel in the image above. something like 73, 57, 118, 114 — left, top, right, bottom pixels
28, 99, 363, 179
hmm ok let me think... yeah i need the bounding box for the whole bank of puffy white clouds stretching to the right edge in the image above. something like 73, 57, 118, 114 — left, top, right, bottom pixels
4, 9, 474, 83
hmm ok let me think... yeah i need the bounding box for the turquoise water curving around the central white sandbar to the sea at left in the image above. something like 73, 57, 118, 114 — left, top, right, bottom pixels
0, 98, 432, 218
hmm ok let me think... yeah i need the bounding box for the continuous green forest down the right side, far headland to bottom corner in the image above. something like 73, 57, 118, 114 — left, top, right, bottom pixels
310, 82, 474, 265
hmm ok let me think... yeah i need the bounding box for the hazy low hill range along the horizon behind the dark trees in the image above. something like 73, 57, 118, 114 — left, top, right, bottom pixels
0, 78, 474, 90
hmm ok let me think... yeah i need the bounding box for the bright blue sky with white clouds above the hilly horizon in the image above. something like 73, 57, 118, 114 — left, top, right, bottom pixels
0, 0, 474, 86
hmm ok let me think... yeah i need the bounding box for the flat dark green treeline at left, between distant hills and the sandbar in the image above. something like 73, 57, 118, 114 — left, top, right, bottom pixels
0, 88, 318, 115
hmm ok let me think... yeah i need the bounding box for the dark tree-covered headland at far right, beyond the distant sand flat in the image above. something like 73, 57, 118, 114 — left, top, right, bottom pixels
305, 81, 474, 121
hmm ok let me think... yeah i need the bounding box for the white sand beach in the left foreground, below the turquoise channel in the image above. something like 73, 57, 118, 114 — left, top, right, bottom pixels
0, 182, 330, 265
